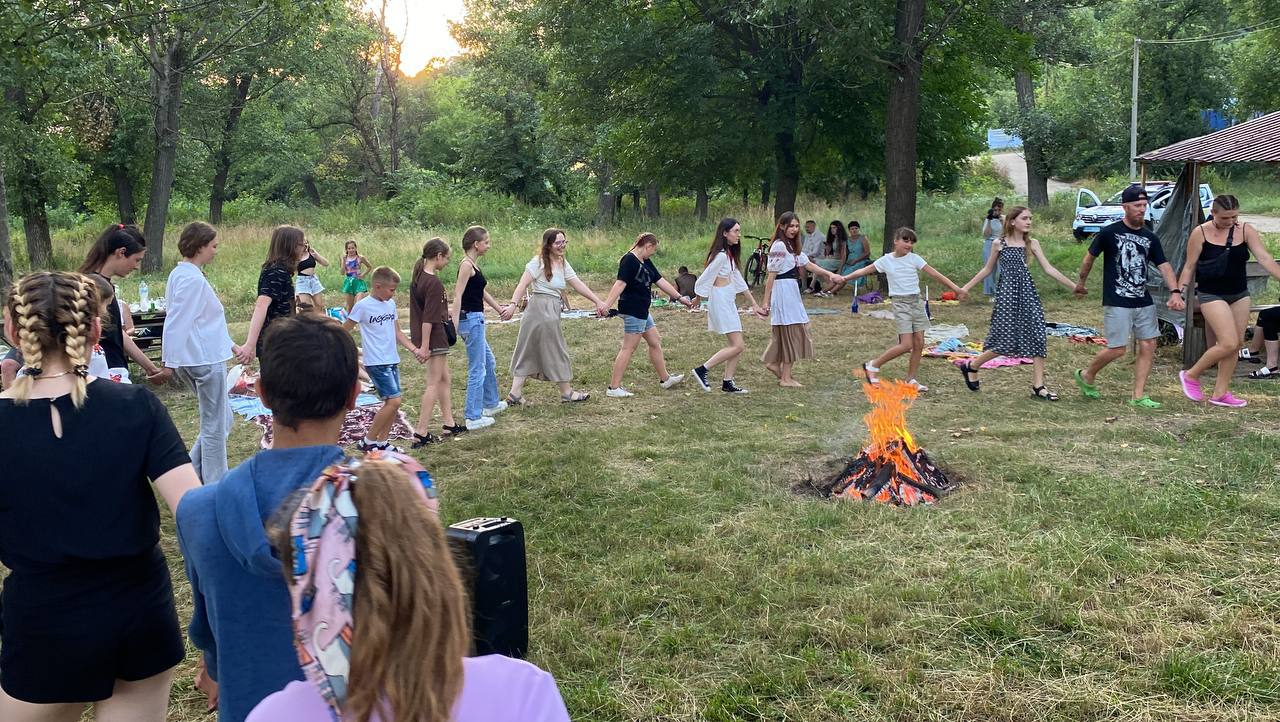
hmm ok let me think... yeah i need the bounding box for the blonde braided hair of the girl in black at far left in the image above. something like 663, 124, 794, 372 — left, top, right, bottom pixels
8, 271, 100, 408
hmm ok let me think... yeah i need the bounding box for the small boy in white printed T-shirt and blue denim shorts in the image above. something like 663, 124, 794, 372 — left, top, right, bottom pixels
342, 266, 428, 452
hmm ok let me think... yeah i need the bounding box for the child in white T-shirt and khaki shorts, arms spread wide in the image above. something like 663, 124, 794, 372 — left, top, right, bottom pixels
844, 225, 969, 392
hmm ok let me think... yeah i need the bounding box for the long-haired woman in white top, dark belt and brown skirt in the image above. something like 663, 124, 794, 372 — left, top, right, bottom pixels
762, 211, 842, 388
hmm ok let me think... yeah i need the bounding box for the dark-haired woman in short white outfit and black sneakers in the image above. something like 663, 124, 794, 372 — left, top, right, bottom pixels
692, 218, 764, 393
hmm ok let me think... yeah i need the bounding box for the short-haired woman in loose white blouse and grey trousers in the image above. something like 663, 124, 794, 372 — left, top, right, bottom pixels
161, 220, 239, 484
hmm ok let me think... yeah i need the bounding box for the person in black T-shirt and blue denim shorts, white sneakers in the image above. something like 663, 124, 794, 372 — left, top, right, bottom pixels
604, 233, 694, 398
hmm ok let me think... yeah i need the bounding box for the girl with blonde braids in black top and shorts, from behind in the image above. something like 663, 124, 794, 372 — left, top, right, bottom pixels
0, 271, 200, 722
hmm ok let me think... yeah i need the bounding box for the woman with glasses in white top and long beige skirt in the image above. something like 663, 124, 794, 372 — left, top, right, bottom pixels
503, 228, 608, 406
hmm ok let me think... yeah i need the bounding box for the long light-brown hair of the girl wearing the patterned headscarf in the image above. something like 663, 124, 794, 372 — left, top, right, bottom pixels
271, 461, 471, 722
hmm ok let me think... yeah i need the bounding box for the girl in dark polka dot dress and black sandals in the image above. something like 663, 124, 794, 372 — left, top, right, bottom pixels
960, 206, 1075, 401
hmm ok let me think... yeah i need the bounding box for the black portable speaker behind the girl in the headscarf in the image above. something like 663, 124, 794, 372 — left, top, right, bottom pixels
448, 516, 529, 659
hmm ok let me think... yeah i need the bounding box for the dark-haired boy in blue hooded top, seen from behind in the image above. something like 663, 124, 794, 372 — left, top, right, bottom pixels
177, 315, 360, 722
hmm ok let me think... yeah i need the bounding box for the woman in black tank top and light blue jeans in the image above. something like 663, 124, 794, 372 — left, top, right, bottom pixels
452, 225, 507, 430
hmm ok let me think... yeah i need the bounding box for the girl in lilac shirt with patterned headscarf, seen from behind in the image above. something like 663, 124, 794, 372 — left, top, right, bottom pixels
247, 452, 568, 722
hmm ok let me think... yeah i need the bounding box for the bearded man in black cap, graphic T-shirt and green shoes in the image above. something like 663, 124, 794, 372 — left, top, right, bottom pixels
1075, 186, 1181, 408
